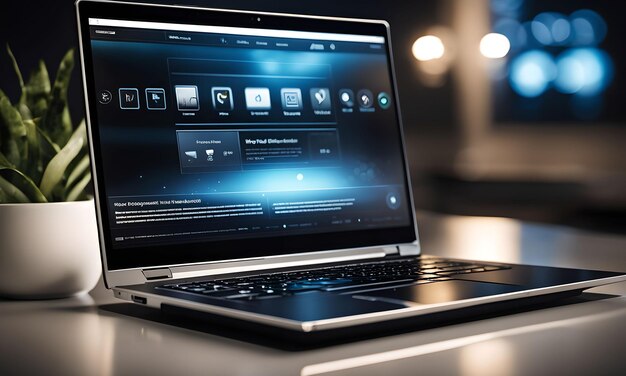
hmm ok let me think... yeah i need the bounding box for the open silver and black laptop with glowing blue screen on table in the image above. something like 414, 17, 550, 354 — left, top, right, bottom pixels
76, 1, 626, 338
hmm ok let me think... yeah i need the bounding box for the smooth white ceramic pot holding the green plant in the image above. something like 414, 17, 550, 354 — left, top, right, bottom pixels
0, 200, 101, 299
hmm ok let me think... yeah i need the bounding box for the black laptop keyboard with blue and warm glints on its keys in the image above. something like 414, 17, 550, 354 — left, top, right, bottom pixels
157, 258, 509, 300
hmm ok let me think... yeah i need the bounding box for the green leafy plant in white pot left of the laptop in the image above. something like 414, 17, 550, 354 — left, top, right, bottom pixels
0, 46, 100, 298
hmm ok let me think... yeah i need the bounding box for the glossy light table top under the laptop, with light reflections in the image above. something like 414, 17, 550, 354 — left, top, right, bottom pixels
0, 215, 626, 376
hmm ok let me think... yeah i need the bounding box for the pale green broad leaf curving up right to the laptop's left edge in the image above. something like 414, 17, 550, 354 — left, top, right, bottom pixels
39, 121, 86, 199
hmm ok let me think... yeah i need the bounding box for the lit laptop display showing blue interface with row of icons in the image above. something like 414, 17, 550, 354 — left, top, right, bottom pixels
83, 2, 413, 268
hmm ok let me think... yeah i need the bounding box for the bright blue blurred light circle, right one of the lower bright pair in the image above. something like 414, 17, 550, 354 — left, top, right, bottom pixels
554, 48, 613, 96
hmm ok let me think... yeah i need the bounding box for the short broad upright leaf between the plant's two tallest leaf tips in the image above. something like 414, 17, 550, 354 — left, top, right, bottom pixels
18, 60, 50, 119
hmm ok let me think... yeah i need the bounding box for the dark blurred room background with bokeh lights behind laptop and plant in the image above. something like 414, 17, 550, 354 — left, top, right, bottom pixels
0, 0, 626, 233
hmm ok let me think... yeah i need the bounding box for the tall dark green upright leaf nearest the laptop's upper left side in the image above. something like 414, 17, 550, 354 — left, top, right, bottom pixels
40, 49, 74, 145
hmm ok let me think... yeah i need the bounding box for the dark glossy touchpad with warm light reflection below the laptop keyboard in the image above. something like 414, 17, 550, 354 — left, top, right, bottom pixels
353, 280, 523, 304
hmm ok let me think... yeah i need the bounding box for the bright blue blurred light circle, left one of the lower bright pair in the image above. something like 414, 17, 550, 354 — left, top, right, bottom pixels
509, 50, 556, 98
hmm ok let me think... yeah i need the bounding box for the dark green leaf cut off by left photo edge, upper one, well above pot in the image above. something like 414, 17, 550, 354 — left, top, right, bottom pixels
0, 91, 27, 167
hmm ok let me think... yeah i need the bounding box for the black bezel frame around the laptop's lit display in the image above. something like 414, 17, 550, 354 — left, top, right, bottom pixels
77, 1, 417, 271
